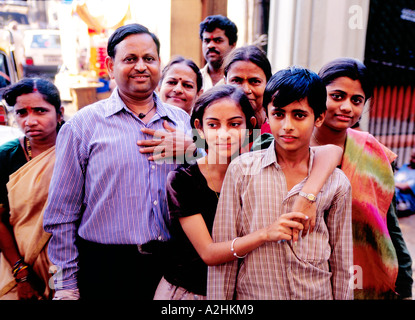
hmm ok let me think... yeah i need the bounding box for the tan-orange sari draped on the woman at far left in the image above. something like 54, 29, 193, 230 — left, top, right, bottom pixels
0, 147, 55, 300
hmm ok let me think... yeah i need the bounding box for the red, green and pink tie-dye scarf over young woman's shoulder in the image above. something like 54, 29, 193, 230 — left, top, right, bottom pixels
342, 129, 398, 299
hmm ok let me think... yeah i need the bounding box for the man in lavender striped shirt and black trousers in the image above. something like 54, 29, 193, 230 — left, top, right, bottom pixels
44, 24, 191, 300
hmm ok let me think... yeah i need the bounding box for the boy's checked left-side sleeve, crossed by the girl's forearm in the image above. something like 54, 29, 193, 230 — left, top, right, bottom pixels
207, 164, 242, 300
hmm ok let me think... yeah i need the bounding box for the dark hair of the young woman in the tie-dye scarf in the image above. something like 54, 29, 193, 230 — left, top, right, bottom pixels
318, 58, 373, 101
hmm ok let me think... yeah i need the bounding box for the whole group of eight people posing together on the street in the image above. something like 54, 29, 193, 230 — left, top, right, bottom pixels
0, 16, 412, 300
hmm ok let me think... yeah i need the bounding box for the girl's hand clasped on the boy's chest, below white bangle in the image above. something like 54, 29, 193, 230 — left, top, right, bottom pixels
266, 212, 308, 242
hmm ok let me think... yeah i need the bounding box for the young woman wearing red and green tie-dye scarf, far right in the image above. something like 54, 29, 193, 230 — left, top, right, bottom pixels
311, 58, 412, 299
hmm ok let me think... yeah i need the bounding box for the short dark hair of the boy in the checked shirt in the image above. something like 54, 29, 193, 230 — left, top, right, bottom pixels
263, 66, 327, 119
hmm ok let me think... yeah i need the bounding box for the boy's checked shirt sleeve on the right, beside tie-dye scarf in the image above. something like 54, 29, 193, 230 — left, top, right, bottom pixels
326, 178, 353, 300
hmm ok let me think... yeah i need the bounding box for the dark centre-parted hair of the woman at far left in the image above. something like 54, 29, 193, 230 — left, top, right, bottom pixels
3, 78, 62, 114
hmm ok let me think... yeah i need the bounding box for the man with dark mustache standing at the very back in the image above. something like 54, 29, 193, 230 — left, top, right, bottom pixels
199, 15, 238, 91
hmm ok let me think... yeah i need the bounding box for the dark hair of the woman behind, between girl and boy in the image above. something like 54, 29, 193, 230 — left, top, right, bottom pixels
223, 45, 272, 81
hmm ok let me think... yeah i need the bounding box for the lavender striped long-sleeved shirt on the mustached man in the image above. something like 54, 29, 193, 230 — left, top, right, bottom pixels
44, 90, 191, 289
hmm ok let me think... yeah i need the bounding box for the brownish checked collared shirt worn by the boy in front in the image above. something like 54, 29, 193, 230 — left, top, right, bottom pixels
207, 142, 353, 300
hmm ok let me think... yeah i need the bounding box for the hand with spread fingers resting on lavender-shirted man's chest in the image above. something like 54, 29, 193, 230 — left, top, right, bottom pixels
137, 121, 196, 161
